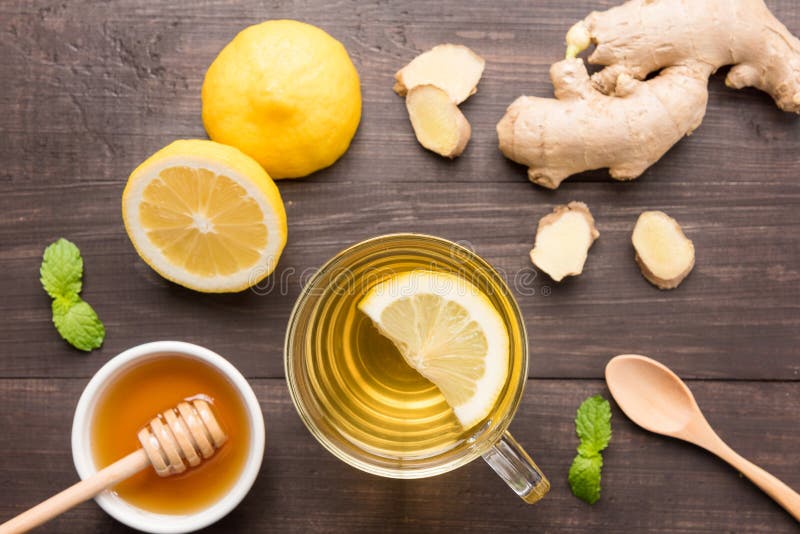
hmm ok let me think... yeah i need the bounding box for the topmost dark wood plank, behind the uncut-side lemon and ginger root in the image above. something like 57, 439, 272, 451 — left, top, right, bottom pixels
0, 0, 800, 191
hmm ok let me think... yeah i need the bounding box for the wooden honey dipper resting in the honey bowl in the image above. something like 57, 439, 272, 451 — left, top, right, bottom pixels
0, 399, 228, 534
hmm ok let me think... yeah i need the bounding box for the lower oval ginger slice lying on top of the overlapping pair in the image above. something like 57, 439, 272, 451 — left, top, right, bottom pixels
406, 85, 472, 158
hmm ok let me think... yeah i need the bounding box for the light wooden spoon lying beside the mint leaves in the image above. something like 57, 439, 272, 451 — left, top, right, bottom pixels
606, 354, 800, 521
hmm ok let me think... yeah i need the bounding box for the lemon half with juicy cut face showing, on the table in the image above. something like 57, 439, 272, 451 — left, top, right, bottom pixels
122, 139, 286, 293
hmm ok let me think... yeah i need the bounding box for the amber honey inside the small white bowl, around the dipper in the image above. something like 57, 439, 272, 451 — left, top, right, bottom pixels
91, 354, 250, 514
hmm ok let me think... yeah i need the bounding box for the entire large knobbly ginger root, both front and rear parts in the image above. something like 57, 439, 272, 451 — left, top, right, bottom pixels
497, 0, 800, 189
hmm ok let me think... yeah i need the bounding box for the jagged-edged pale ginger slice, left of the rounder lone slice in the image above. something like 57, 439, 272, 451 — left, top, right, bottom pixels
531, 202, 600, 282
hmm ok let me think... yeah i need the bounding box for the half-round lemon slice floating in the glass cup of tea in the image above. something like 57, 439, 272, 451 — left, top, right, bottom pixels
358, 270, 509, 429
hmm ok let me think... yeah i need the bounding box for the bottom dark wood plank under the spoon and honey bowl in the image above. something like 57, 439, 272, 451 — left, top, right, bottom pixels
0, 379, 800, 533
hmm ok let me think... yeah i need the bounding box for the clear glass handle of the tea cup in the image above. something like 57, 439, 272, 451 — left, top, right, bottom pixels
483, 432, 550, 504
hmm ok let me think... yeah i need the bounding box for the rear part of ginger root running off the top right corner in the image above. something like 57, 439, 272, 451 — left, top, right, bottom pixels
572, 0, 800, 113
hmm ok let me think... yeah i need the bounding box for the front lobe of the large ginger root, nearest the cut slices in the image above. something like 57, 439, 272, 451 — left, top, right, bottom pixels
497, 59, 710, 189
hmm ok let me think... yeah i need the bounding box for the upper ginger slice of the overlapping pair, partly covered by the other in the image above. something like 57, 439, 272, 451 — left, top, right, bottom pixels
394, 44, 486, 105
